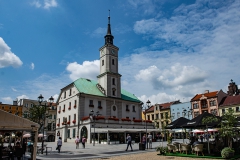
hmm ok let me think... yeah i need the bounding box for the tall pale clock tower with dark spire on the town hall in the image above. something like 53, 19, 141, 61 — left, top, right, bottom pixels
97, 12, 121, 98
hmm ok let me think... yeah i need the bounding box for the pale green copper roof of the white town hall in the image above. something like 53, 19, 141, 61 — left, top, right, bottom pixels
73, 78, 141, 102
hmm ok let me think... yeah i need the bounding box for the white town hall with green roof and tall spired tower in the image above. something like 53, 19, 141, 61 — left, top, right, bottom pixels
56, 16, 154, 144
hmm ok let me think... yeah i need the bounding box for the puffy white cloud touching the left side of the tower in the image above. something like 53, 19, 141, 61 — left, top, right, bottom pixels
66, 60, 100, 81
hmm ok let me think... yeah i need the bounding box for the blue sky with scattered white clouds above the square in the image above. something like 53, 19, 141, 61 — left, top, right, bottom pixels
0, 0, 240, 104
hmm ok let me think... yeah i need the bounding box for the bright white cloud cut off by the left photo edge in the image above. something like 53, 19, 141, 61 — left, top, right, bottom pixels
0, 37, 23, 68
